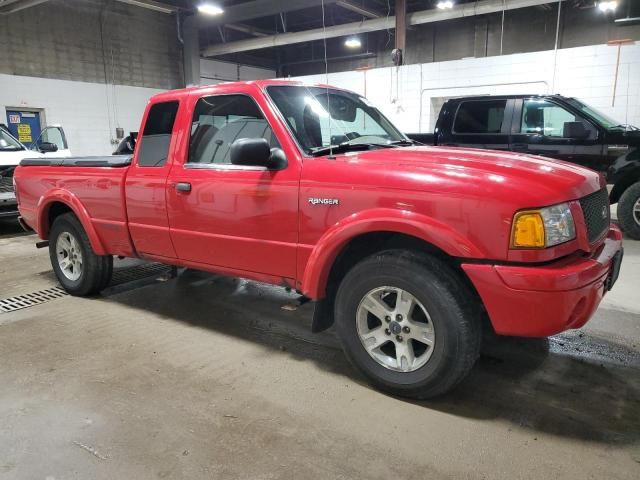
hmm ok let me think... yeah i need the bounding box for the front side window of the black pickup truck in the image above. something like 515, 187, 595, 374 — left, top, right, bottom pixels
520, 99, 595, 138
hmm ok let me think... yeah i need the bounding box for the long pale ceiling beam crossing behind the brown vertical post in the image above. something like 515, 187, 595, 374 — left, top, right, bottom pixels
202, 0, 566, 57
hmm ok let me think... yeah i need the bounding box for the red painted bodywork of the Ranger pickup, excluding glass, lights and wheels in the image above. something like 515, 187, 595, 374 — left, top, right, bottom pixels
15, 81, 621, 335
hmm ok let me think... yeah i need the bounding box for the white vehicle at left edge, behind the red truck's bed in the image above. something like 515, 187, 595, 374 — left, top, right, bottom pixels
0, 125, 71, 218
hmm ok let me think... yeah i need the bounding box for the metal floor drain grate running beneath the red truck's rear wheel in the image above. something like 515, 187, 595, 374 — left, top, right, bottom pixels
0, 263, 171, 313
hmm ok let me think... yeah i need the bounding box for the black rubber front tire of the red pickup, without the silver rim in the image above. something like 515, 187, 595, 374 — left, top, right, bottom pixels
335, 250, 482, 399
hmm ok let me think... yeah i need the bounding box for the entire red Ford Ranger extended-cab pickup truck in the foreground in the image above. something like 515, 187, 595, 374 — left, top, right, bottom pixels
14, 81, 622, 398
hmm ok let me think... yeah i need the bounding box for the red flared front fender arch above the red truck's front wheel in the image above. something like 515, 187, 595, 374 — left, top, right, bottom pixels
302, 208, 485, 299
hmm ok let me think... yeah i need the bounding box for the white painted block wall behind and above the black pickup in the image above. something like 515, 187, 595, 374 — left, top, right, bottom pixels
296, 42, 640, 133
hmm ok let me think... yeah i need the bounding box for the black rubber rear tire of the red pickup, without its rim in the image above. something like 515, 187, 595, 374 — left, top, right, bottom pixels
49, 213, 113, 297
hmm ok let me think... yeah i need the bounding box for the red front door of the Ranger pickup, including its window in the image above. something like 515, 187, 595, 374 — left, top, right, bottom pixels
167, 94, 300, 279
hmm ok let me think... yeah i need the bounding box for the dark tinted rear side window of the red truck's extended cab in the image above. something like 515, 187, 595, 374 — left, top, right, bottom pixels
138, 101, 178, 167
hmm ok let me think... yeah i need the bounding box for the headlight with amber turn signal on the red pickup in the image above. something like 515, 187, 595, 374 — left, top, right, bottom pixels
511, 203, 576, 248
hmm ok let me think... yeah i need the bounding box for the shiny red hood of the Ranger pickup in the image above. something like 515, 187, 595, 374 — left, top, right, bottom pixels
337, 147, 606, 207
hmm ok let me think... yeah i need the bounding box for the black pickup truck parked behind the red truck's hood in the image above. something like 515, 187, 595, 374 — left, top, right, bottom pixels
407, 95, 640, 240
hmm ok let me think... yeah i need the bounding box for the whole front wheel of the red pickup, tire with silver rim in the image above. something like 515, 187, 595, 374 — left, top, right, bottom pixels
335, 250, 482, 399
